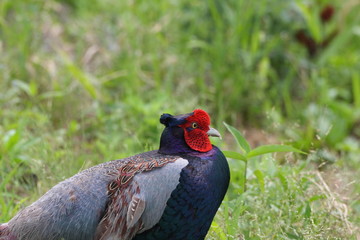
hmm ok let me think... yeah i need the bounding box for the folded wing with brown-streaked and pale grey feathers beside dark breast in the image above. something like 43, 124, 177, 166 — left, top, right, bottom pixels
95, 156, 188, 240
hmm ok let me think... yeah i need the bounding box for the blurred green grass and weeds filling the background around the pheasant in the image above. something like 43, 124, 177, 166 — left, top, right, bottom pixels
0, 0, 360, 239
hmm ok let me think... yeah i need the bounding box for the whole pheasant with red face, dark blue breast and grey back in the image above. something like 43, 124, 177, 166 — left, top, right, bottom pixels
0, 109, 230, 240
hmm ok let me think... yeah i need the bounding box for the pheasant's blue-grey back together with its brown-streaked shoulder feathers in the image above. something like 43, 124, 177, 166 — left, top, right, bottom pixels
0, 150, 178, 240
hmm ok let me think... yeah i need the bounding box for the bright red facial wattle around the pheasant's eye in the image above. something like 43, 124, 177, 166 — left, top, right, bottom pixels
180, 109, 212, 152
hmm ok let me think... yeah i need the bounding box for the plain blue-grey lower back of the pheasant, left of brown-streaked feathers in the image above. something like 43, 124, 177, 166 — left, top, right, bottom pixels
8, 161, 124, 240
